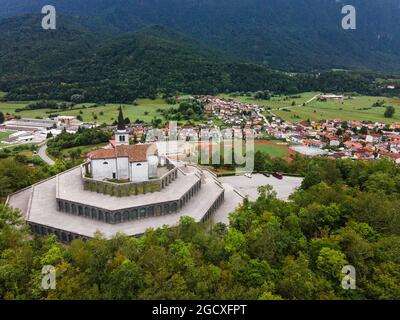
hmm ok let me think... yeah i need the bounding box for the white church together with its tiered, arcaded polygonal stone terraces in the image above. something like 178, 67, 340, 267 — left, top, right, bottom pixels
6, 109, 227, 243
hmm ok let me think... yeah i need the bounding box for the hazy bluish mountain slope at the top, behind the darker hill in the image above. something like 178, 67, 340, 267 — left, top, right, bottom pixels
0, 0, 400, 72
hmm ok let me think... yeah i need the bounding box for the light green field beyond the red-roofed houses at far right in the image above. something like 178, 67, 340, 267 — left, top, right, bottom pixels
267, 96, 400, 123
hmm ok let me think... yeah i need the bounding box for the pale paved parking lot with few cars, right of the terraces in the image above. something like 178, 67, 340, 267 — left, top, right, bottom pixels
219, 174, 303, 200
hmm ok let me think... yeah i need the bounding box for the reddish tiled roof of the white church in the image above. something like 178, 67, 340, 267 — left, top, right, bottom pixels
88, 144, 157, 162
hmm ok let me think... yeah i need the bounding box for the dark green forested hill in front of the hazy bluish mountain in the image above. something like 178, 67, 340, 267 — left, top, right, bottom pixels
0, 15, 397, 103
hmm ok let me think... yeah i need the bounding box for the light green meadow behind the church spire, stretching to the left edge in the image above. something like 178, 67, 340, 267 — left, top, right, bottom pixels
0, 99, 176, 124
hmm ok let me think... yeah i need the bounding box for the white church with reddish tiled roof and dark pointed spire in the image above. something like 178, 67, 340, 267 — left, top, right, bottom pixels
88, 108, 160, 182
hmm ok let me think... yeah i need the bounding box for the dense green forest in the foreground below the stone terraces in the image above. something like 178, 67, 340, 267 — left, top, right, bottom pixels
0, 158, 400, 300
